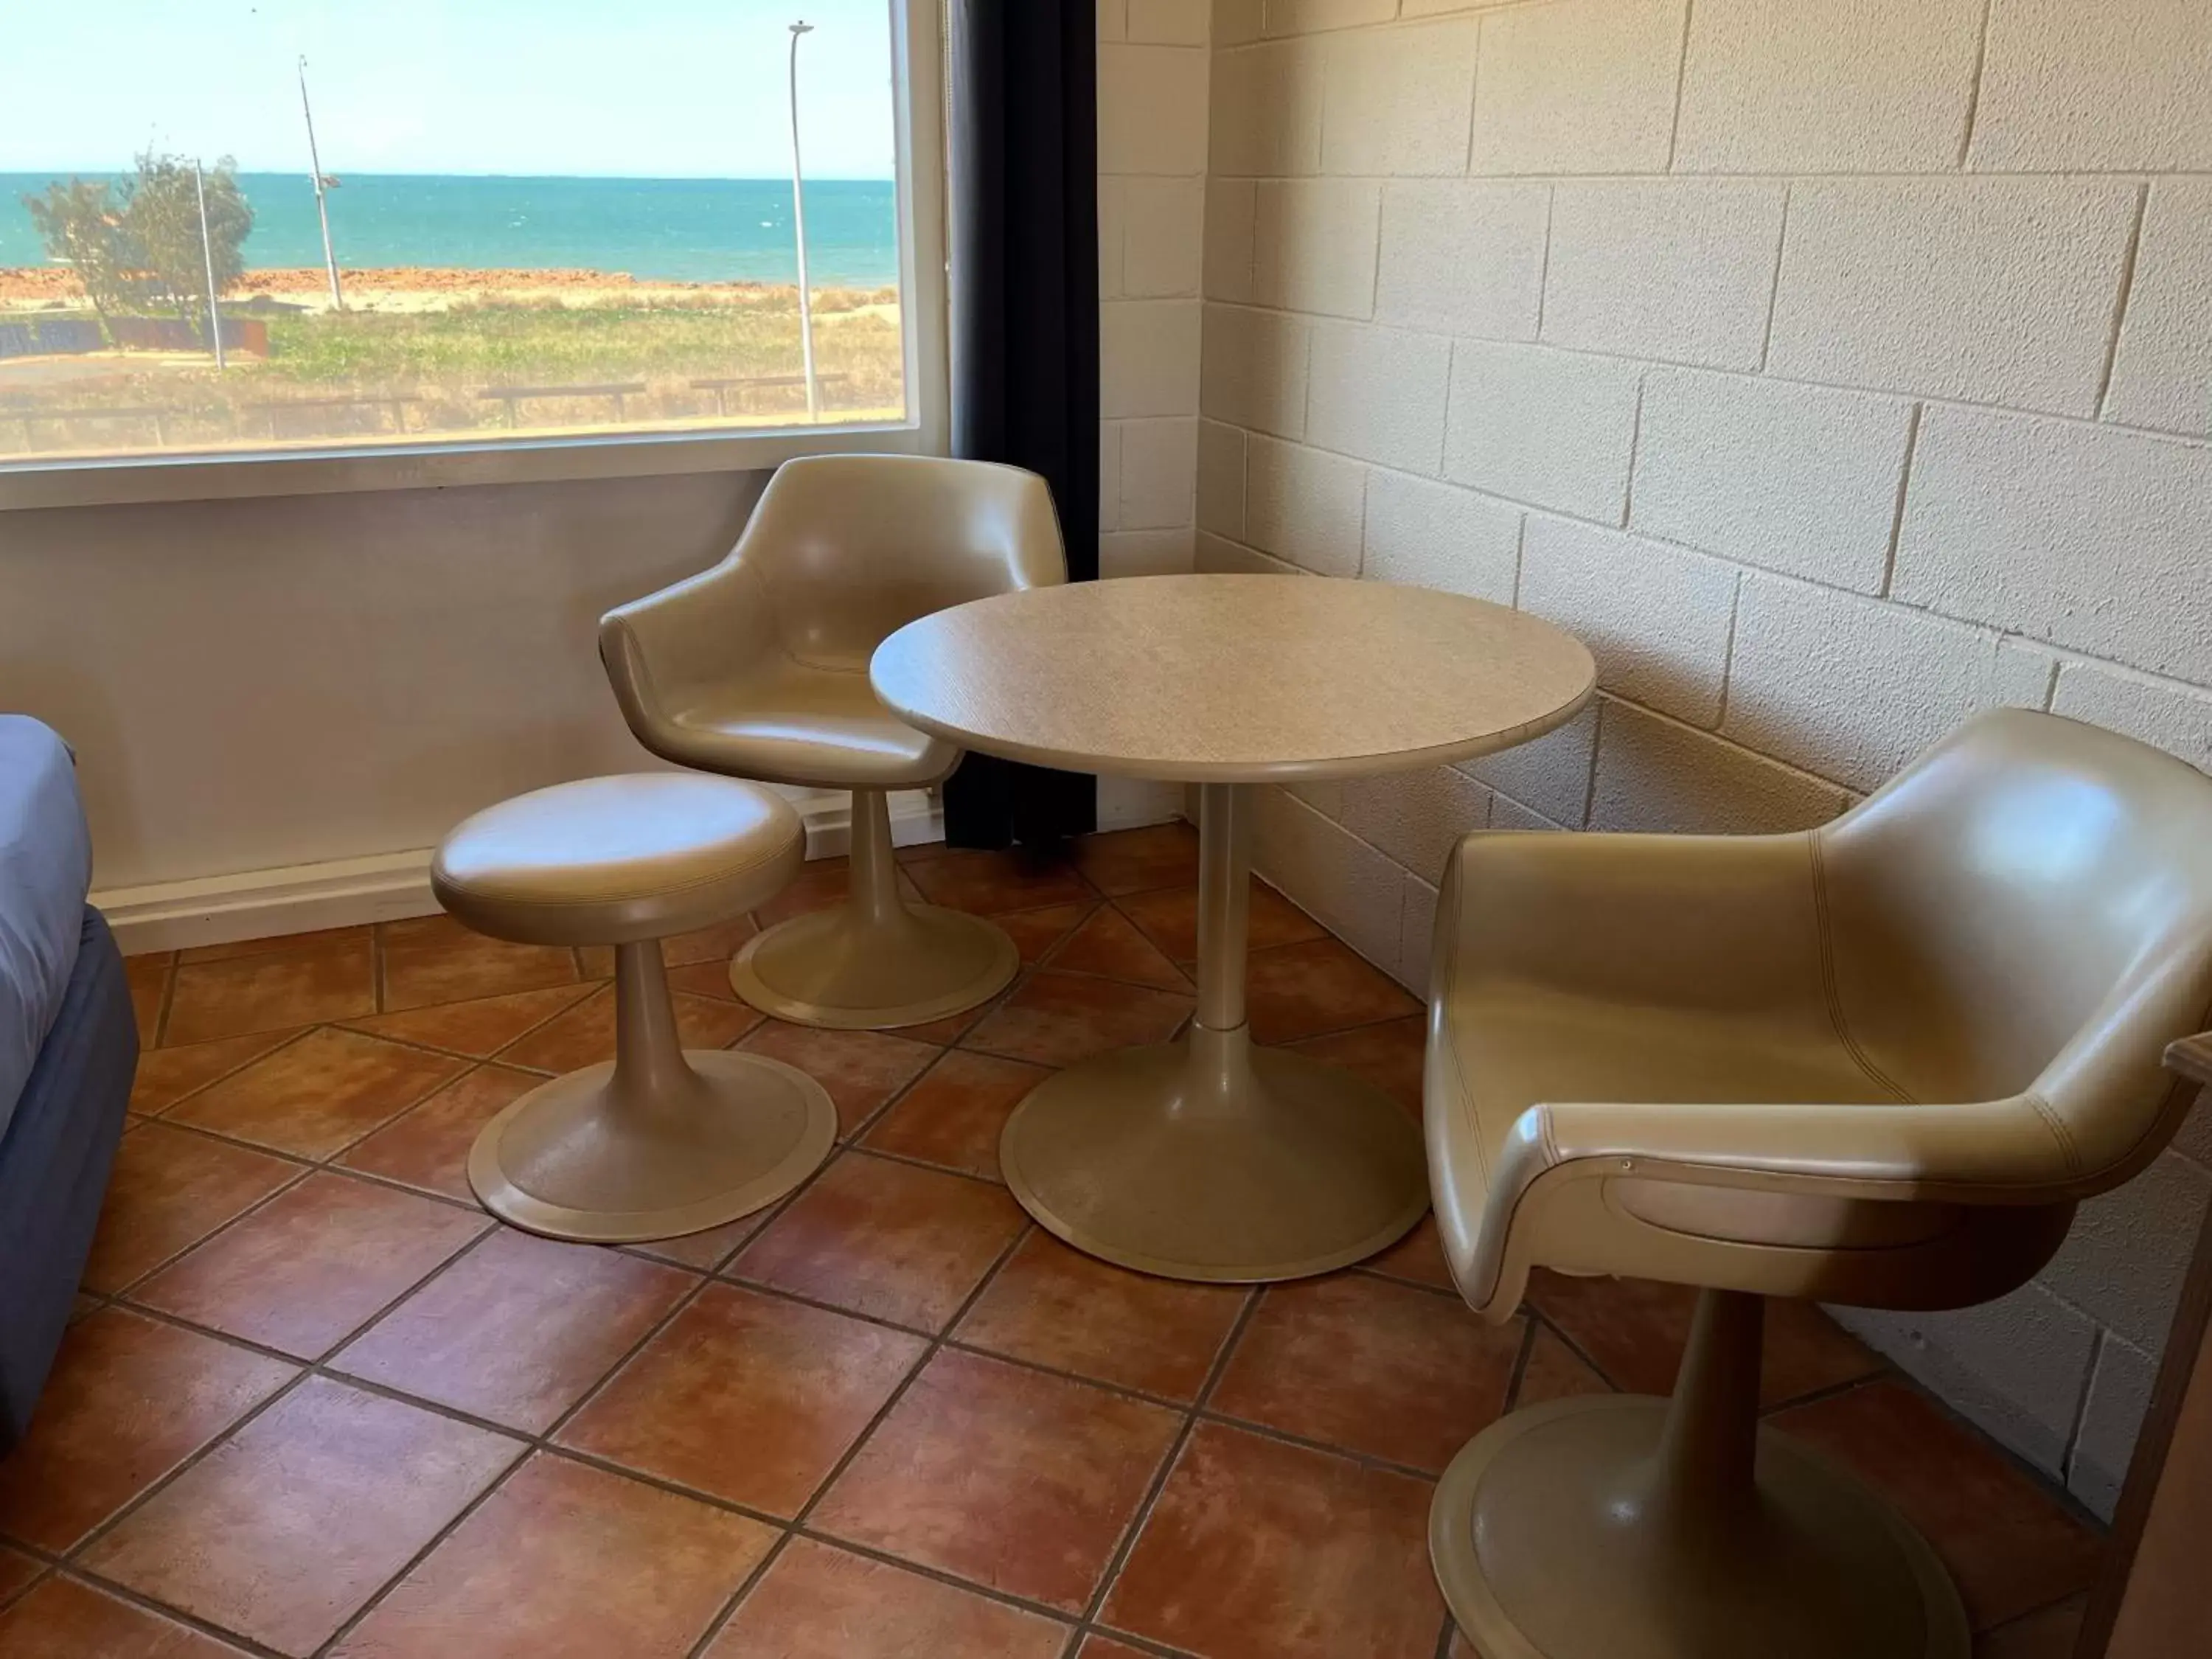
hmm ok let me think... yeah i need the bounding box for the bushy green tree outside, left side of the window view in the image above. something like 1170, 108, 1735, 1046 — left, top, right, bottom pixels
22, 150, 254, 345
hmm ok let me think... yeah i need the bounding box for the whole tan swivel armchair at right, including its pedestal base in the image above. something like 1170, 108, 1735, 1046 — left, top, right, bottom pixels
1427, 710, 2212, 1659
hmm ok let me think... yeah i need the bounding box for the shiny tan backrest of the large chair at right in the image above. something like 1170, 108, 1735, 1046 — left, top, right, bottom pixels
1814, 710, 2212, 1175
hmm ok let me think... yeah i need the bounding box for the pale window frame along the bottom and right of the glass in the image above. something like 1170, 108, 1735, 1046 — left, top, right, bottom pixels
0, 0, 951, 511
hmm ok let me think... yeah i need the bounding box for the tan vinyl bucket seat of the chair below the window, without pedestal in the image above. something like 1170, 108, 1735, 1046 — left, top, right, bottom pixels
599, 456, 1066, 790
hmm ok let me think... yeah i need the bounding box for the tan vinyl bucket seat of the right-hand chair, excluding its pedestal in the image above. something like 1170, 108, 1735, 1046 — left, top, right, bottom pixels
1425, 710, 2212, 1318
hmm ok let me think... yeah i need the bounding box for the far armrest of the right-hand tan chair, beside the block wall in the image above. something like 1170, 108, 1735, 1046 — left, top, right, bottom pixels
1429, 832, 1825, 1009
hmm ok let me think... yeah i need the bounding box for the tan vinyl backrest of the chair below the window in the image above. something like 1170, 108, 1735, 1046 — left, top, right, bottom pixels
734, 456, 1068, 668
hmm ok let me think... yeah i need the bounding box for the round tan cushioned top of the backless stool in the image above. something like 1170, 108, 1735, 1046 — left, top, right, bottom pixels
431, 772, 805, 945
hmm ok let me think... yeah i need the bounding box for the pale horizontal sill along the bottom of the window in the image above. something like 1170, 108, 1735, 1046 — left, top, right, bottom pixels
0, 422, 933, 511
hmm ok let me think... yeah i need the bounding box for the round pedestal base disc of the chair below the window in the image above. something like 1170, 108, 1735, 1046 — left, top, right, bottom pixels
730, 905, 1022, 1031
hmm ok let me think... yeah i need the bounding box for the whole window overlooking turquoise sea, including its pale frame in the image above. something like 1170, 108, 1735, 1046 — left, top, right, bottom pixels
0, 0, 945, 507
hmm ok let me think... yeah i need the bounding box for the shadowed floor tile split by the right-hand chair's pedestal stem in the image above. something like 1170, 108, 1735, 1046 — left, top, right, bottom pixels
1528, 1267, 1882, 1407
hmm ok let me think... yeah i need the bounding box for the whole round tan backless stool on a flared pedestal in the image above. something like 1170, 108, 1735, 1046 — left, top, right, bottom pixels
431, 772, 836, 1243
